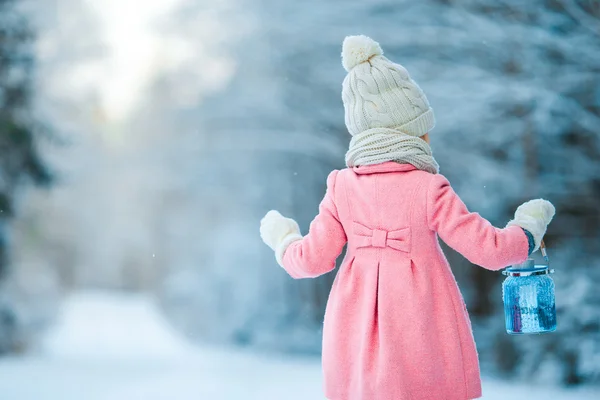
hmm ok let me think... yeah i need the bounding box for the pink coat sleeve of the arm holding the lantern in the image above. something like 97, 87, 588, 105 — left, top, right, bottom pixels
427, 175, 529, 270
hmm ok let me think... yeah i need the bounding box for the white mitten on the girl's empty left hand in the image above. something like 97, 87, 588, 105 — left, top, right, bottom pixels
260, 210, 302, 266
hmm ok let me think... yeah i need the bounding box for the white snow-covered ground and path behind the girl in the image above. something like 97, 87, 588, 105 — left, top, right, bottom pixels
0, 293, 600, 400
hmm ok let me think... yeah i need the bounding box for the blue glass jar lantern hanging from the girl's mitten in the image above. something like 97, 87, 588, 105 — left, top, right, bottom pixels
502, 244, 556, 335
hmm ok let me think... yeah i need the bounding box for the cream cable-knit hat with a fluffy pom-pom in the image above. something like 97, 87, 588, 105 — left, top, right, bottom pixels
342, 35, 435, 137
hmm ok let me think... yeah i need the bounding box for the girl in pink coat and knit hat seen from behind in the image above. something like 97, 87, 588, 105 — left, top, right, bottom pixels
260, 36, 554, 400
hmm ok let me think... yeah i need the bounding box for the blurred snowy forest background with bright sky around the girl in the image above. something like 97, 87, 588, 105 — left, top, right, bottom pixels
0, 0, 600, 390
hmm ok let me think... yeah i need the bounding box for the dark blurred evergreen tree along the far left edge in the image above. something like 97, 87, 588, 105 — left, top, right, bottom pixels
0, 0, 50, 353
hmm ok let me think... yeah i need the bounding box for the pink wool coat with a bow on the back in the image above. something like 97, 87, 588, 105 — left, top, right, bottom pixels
282, 162, 529, 400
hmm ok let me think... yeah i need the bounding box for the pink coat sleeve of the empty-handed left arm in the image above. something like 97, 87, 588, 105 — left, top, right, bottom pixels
282, 171, 347, 279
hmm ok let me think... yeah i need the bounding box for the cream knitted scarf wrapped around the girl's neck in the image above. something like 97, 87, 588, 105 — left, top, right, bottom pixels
346, 128, 440, 174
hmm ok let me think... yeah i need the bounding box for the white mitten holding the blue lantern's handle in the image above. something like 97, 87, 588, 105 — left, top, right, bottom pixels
506, 199, 556, 252
